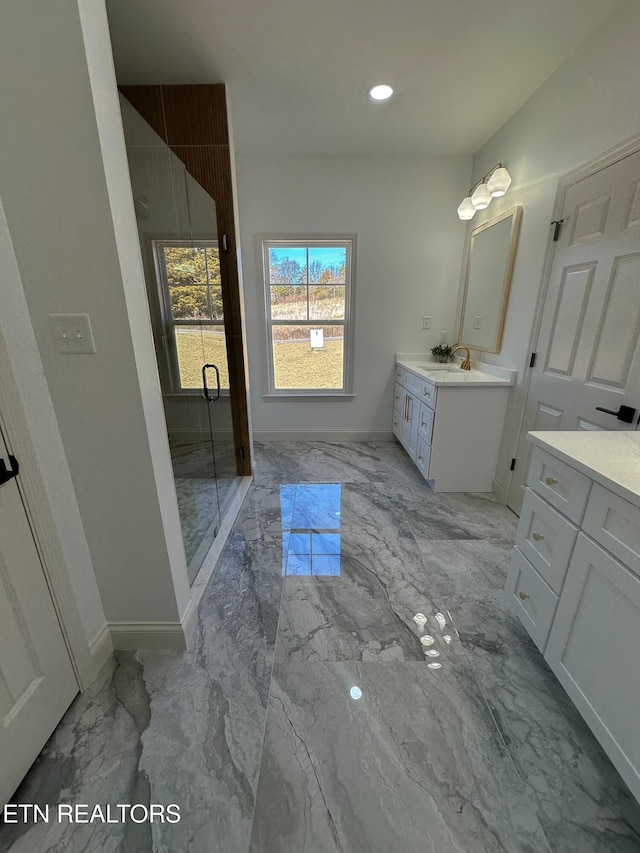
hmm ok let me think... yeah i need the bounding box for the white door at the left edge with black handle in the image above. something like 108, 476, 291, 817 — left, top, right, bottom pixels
0, 426, 78, 806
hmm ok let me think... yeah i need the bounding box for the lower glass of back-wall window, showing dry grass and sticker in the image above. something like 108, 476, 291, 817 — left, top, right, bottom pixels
271, 325, 344, 390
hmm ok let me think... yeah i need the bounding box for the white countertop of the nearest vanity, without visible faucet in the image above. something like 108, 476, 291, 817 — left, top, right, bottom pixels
527, 430, 640, 506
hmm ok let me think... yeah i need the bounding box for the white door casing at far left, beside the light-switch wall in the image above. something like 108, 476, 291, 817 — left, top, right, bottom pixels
0, 328, 97, 690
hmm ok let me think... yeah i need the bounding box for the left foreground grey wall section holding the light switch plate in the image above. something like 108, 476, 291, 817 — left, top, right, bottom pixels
0, 0, 190, 623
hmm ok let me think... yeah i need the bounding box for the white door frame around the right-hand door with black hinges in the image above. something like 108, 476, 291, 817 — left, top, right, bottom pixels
503, 134, 640, 504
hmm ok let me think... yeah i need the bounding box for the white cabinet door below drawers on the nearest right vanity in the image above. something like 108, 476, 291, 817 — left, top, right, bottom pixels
545, 533, 640, 799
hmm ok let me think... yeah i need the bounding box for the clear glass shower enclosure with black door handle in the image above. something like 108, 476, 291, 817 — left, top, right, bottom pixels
120, 96, 238, 583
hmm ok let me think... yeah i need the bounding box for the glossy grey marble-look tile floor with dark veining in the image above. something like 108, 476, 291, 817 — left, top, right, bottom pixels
0, 443, 640, 853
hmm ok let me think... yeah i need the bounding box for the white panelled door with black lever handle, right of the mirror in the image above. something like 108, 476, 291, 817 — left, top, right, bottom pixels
507, 152, 640, 513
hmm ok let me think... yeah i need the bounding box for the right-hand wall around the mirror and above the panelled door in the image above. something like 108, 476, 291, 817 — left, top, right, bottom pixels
458, 0, 640, 500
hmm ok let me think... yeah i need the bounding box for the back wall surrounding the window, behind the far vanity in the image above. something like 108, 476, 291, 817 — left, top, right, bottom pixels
233, 154, 471, 437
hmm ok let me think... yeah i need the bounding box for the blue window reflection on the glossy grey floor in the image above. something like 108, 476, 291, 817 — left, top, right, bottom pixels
280, 483, 342, 577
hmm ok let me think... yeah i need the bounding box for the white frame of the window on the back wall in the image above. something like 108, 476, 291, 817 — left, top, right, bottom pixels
256, 234, 357, 400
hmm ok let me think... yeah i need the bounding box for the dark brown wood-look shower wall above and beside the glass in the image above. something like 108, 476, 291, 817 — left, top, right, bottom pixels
120, 83, 252, 476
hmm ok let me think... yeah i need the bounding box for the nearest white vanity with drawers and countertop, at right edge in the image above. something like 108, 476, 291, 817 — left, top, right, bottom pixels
505, 432, 640, 800
